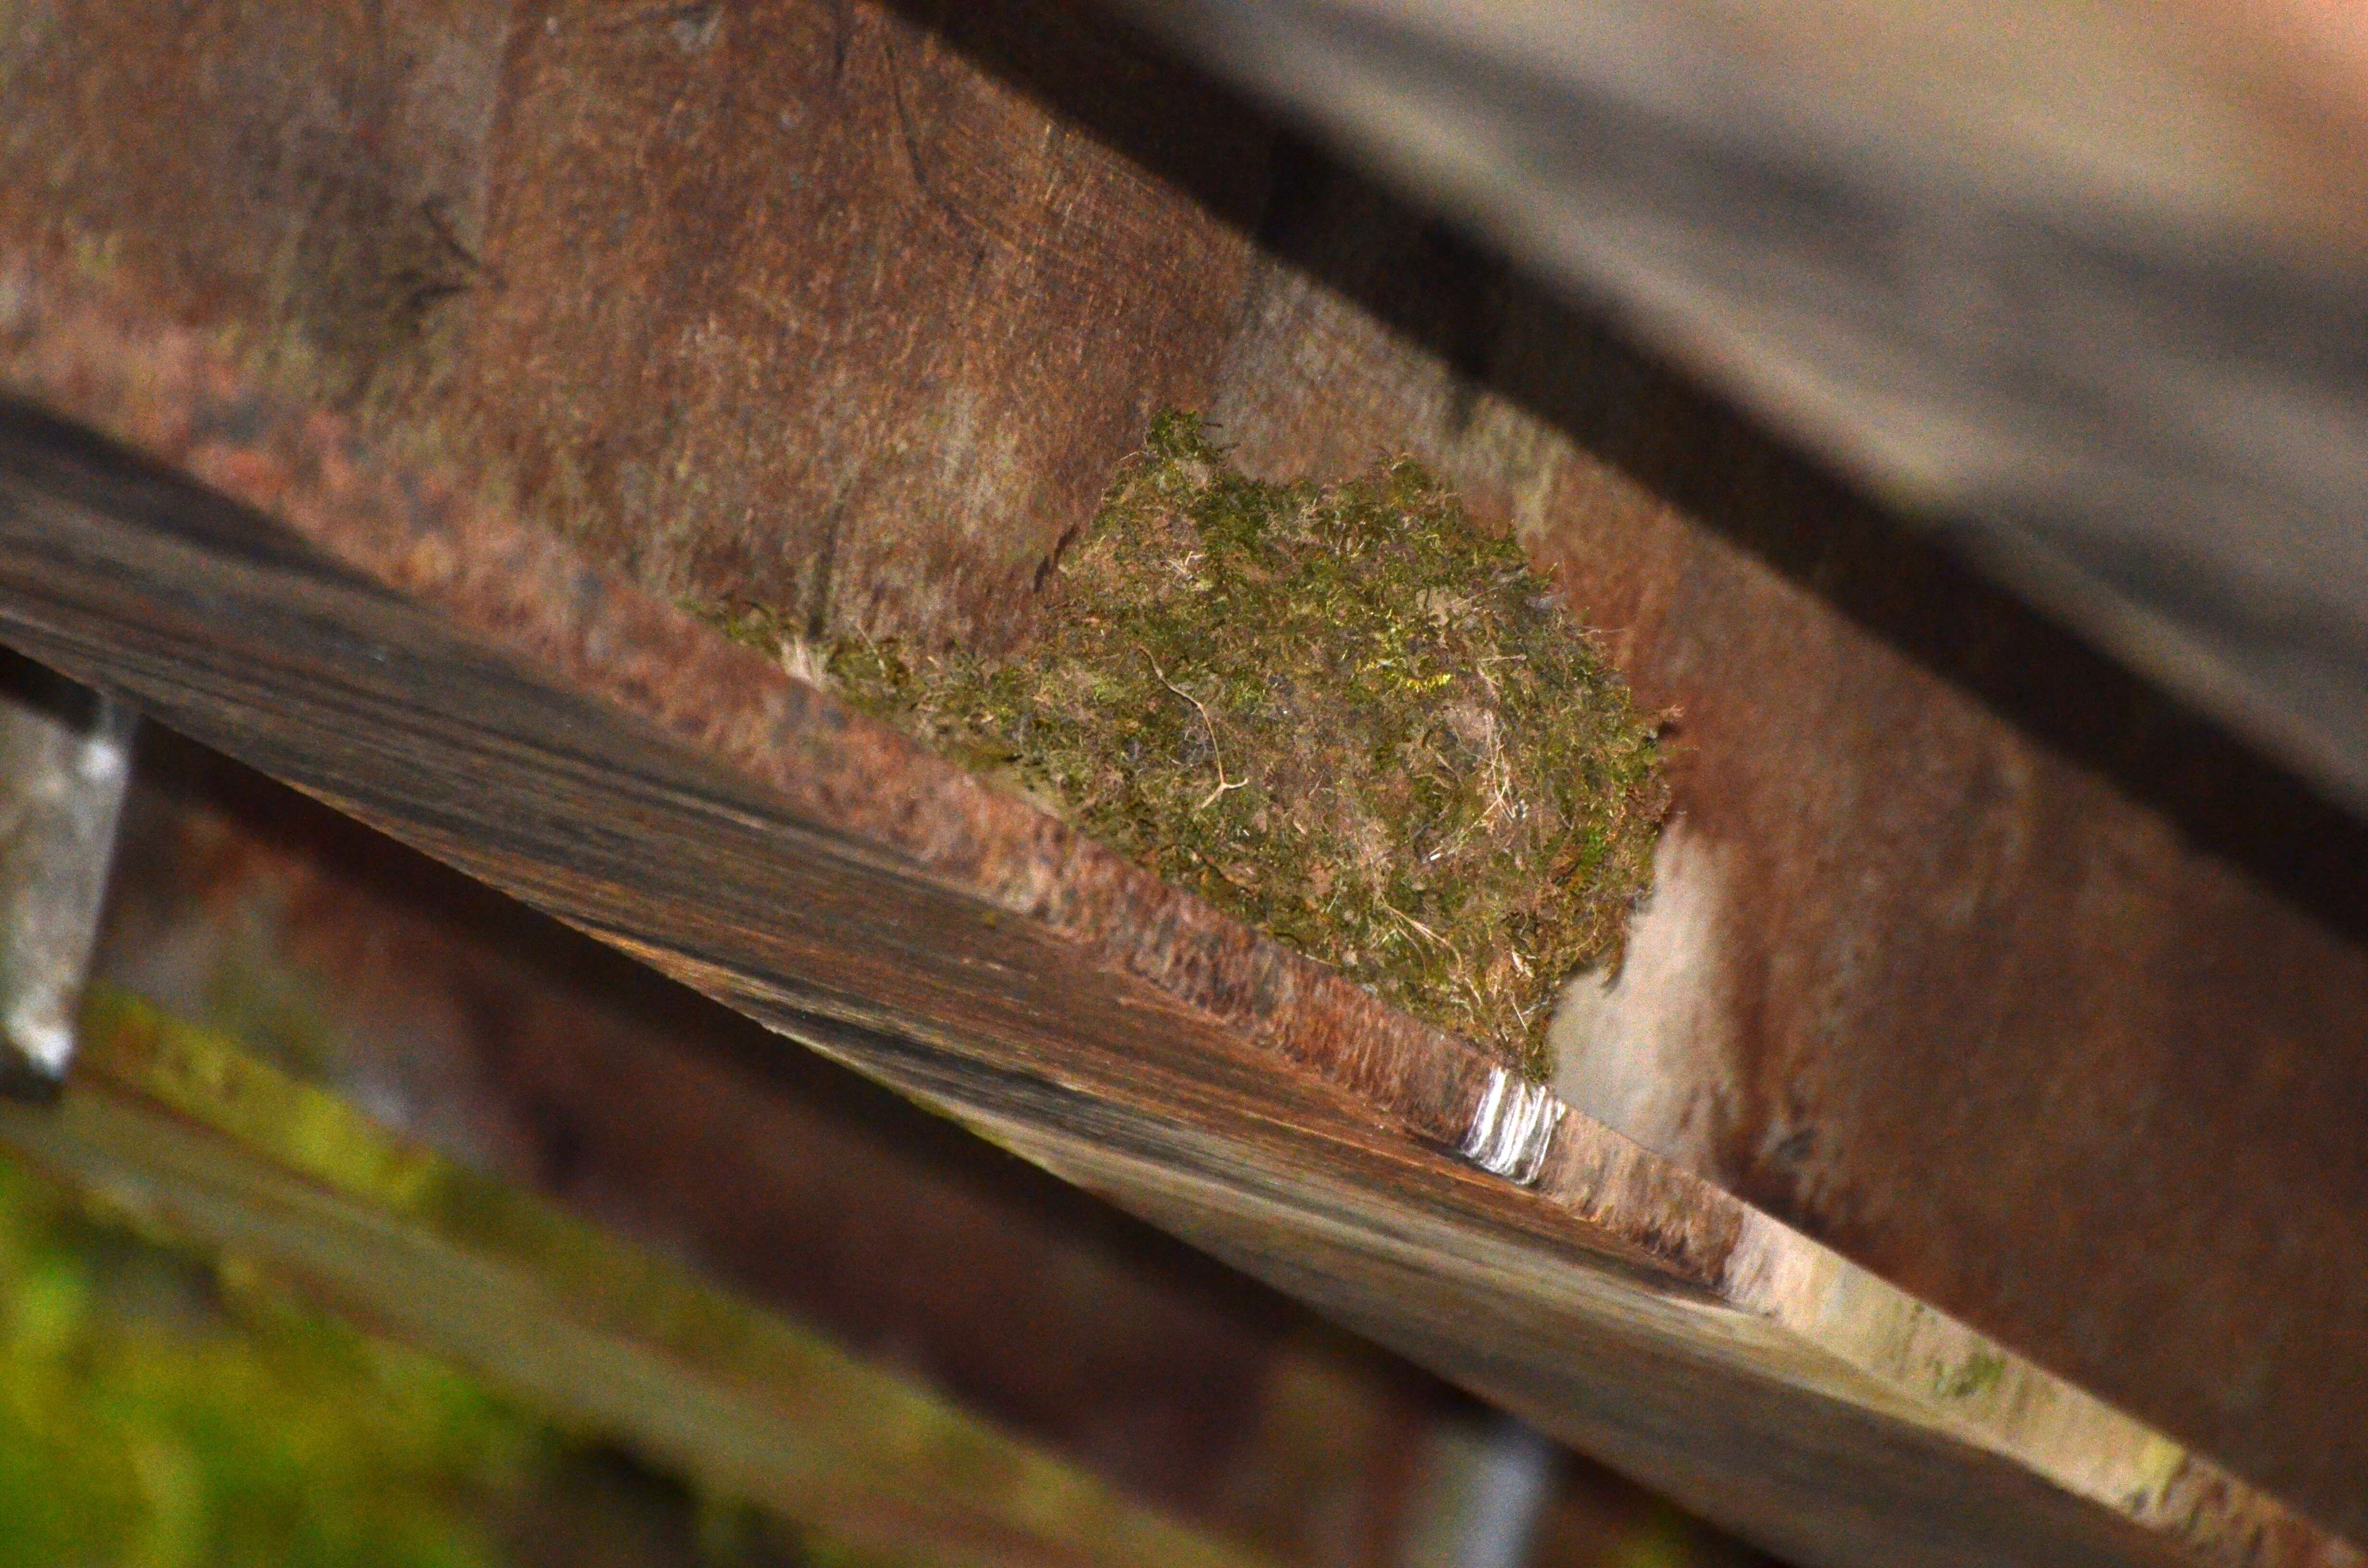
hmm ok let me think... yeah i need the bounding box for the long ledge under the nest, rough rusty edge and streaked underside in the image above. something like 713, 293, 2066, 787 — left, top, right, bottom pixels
0, 265, 2361, 1568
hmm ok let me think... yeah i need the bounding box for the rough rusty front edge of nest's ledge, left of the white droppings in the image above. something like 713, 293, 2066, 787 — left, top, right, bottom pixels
0, 255, 1534, 1241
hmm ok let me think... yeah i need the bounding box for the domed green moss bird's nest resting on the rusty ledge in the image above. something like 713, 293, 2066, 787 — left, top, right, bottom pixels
706, 415, 1662, 1078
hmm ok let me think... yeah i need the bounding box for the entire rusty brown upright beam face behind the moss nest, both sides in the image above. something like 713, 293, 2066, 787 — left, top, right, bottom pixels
0, 0, 2368, 1563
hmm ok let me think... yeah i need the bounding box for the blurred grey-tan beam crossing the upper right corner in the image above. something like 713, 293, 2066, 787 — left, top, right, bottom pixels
1113, 0, 2368, 810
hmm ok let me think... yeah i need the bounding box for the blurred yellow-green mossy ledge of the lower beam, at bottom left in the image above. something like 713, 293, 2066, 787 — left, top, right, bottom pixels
0, 988, 1265, 1568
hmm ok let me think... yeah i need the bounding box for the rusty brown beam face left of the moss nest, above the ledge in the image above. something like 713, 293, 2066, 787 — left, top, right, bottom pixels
0, 0, 1274, 644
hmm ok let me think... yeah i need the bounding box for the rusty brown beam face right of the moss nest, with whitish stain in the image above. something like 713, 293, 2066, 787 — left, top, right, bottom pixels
1193, 212, 2368, 1535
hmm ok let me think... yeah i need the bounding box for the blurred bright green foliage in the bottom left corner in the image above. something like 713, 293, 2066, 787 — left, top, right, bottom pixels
0, 1161, 549, 1568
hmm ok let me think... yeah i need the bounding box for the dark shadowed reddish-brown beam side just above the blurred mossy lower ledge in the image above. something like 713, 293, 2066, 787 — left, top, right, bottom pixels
97, 730, 1762, 1568
